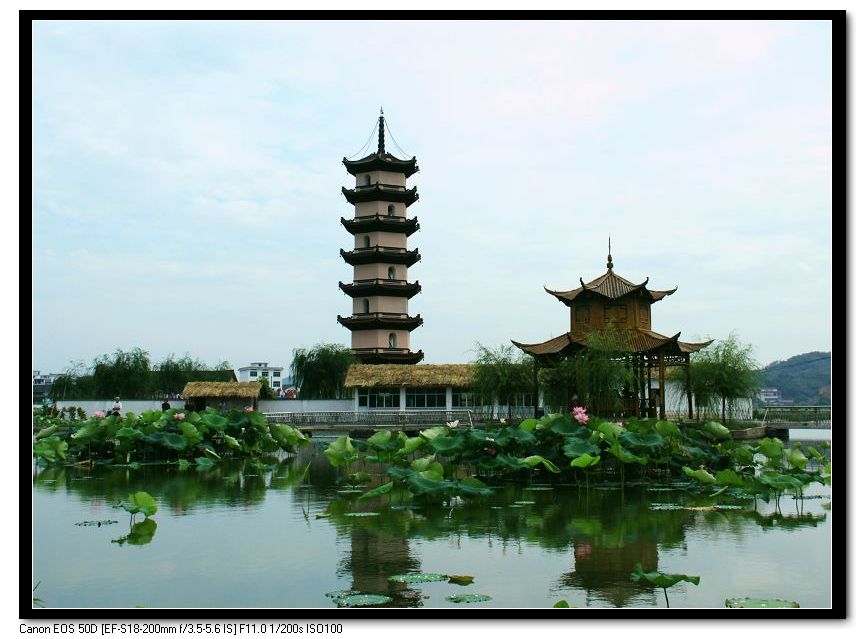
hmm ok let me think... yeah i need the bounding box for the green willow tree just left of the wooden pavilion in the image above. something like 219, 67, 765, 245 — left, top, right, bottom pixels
472, 344, 533, 419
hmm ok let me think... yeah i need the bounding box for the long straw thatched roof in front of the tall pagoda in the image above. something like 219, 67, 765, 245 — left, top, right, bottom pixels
345, 364, 474, 388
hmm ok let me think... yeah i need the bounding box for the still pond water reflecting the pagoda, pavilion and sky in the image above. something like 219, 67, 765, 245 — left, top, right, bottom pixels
33, 433, 832, 609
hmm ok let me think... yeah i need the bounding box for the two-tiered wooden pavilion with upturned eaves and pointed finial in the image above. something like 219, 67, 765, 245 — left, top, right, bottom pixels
511, 247, 712, 419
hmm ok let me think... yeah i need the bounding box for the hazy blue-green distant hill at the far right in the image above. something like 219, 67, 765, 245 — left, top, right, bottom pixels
762, 351, 832, 406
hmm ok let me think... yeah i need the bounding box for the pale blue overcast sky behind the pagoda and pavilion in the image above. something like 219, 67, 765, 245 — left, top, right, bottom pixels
33, 22, 832, 372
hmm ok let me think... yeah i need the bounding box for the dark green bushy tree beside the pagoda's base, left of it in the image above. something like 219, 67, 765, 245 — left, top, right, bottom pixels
291, 344, 357, 399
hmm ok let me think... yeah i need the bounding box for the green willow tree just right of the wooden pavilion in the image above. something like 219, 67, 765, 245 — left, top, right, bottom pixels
671, 332, 761, 422
